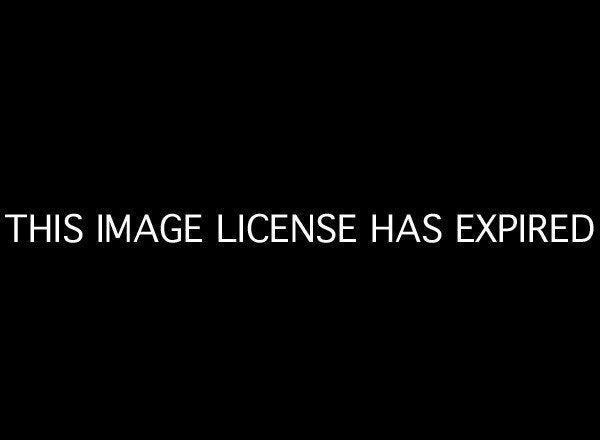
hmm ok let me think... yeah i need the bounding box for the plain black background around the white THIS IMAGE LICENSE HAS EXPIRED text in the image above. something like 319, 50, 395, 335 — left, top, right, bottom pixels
1, 5, 598, 433
